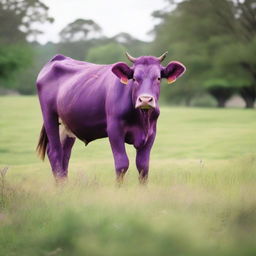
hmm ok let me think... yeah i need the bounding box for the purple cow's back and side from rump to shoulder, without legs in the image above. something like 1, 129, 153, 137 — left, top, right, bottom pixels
37, 55, 115, 141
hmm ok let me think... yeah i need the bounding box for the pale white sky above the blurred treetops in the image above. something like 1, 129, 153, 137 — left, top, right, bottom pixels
38, 0, 168, 43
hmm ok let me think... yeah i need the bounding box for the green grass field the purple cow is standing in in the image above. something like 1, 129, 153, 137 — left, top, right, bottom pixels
0, 96, 256, 256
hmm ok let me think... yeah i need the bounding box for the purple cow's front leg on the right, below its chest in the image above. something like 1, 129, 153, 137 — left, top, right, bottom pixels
136, 134, 155, 184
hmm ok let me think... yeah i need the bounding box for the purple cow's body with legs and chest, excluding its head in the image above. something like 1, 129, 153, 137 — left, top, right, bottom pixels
37, 55, 185, 183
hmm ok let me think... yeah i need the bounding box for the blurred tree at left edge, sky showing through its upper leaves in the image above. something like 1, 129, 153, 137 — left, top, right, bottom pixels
0, 0, 53, 92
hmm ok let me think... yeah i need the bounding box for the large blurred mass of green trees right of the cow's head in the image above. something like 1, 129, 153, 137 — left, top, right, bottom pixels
150, 0, 256, 107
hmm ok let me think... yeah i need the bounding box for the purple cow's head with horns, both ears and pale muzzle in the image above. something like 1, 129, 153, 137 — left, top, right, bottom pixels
112, 52, 186, 109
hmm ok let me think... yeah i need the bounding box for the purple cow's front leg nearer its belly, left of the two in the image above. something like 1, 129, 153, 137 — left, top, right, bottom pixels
108, 124, 129, 184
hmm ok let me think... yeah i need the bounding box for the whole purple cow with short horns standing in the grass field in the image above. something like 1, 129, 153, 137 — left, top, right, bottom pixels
37, 52, 185, 183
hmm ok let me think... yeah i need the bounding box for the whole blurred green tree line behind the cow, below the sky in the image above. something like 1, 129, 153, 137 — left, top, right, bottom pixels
0, 0, 256, 108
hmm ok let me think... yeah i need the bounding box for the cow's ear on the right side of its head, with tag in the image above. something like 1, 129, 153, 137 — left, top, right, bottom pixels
161, 61, 186, 84
